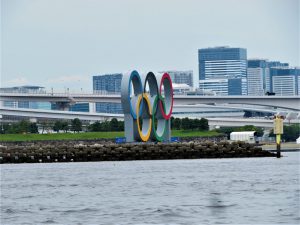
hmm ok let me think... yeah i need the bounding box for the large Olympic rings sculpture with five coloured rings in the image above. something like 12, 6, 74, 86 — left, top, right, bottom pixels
121, 70, 173, 142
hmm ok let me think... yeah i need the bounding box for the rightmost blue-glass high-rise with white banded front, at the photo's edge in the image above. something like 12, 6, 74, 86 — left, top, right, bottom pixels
270, 67, 300, 96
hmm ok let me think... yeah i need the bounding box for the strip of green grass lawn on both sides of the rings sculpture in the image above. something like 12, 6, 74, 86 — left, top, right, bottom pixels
0, 130, 220, 142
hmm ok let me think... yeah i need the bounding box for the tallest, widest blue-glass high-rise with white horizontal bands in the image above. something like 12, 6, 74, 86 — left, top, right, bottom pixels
198, 47, 248, 95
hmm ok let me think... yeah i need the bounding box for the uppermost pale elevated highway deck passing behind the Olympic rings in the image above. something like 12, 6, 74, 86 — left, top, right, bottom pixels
0, 93, 300, 111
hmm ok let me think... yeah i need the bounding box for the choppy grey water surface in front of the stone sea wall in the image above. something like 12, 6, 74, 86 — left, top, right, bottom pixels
1, 152, 300, 224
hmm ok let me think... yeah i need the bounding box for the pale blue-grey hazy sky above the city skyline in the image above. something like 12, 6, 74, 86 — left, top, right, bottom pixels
0, 0, 300, 92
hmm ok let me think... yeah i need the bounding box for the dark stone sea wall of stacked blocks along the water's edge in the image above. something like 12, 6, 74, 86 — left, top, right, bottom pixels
0, 141, 275, 163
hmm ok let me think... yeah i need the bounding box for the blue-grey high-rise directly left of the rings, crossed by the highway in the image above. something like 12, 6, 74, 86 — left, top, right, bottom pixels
93, 73, 123, 113
